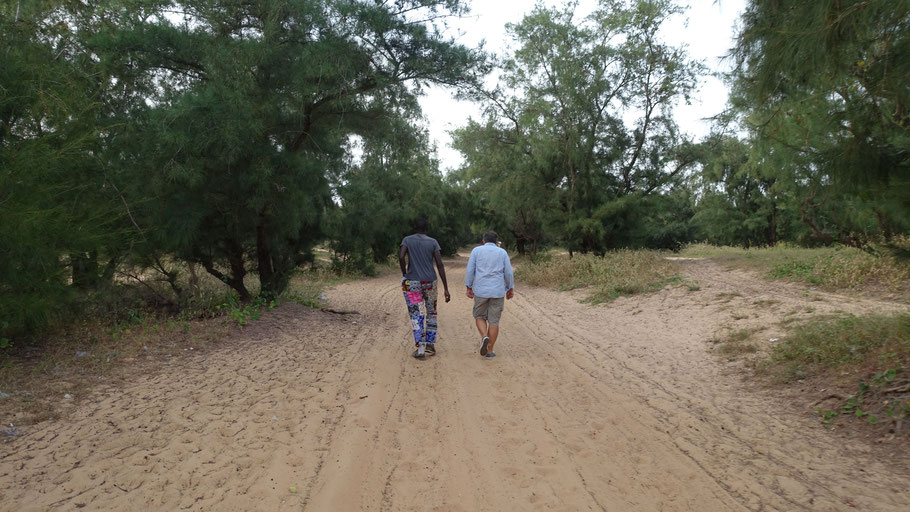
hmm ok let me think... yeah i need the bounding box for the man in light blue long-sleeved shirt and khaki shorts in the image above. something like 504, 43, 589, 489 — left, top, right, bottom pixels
464, 231, 515, 359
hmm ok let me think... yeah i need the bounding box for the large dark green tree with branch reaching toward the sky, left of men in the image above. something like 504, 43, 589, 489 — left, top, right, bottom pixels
88, 0, 476, 300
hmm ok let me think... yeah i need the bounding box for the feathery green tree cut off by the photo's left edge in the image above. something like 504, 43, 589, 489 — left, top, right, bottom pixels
0, 2, 129, 335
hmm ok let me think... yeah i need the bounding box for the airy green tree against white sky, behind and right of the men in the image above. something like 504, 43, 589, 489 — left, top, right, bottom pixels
455, 0, 700, 254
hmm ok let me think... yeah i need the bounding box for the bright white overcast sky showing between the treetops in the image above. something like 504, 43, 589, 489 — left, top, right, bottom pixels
420, 0, 746, 171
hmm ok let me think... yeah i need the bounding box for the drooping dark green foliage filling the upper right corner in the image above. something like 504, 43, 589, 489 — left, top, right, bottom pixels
732, 0, 910, 246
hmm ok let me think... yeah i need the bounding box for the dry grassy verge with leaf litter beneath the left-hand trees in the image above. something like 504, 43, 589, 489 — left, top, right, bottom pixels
0, 258, 378, 430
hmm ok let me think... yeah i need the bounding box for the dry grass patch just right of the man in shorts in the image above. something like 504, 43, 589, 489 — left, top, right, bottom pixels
515, 249, 697, 304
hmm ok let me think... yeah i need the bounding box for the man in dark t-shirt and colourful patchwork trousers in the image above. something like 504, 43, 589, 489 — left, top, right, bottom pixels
398, 219, 452, 358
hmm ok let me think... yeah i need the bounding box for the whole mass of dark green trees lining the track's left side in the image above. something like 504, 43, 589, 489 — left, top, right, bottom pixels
0, 0, 481, 337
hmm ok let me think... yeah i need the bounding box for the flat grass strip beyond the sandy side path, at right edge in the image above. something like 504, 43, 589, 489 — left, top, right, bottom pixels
681, 244, 910, 297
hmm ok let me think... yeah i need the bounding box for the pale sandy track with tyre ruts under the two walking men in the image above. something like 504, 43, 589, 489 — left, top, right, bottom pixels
0, 258, 910, 512
